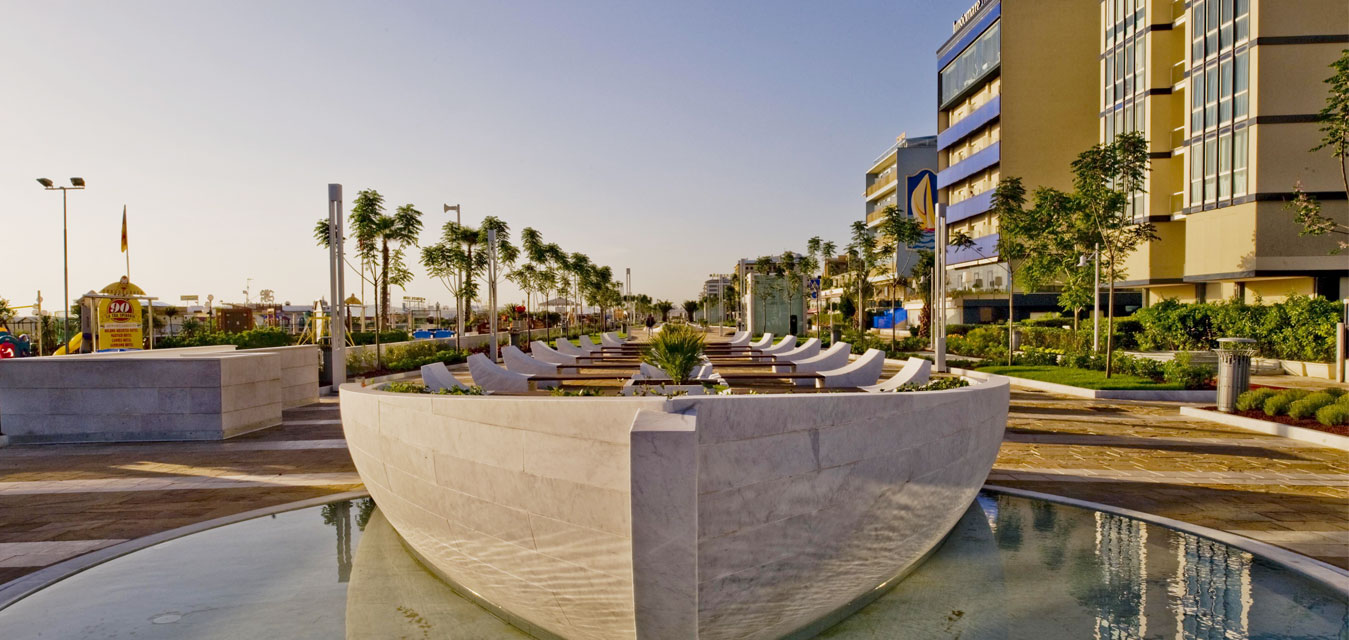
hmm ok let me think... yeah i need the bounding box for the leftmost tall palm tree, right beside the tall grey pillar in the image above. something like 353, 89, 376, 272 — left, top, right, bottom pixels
314, 189, 422, 367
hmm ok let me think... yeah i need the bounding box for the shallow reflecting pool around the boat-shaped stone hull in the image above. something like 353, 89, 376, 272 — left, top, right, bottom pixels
0, 493, 1349, 640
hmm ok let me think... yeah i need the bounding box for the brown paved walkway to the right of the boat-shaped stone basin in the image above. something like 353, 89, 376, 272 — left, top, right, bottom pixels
989, 386, 1349, 568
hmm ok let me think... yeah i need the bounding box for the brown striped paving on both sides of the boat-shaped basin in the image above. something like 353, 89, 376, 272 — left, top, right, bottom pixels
0, 380, 1349, 582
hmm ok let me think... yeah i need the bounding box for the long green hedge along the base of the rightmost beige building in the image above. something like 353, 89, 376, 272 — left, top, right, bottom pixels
1135, 296, 1342, 362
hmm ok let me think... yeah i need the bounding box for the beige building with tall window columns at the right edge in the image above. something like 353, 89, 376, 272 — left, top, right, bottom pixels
1106, 0, 1349, 304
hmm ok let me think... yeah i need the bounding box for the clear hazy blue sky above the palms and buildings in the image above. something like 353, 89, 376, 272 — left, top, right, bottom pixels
0, 0, 970, 308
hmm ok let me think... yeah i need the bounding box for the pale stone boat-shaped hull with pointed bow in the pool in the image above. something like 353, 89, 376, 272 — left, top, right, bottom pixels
341, 377, 1009, 639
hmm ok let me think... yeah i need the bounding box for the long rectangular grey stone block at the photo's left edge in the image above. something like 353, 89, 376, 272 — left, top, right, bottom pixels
0, 351, 282, 444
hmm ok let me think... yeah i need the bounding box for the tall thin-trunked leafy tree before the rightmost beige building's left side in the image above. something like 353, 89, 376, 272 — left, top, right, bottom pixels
1072, 131, 1157, 378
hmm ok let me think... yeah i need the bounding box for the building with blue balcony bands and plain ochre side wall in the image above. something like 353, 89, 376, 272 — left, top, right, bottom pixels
936, 0, 1111, 323
